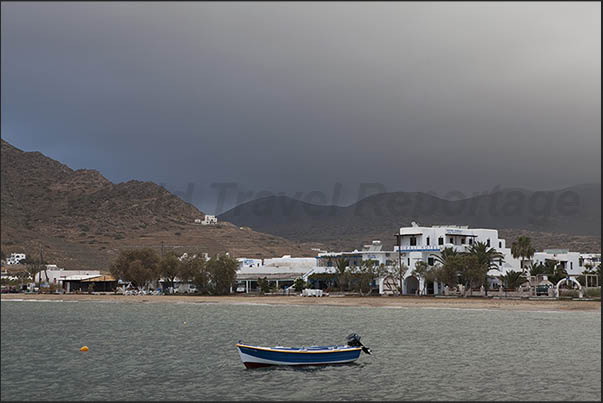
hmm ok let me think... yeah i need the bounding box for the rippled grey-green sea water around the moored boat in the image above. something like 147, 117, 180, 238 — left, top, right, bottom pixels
0, 301, 601, 400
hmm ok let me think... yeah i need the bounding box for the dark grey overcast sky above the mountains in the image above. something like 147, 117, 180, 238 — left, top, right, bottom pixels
1, 2, 601, 213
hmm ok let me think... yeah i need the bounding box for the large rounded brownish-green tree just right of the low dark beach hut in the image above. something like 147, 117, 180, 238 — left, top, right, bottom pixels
109, 248, 159, 288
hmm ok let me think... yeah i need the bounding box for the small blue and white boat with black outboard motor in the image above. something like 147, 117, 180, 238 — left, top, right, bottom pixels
237, 333, 371, 368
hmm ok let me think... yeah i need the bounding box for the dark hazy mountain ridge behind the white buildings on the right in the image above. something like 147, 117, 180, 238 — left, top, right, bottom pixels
219, 184, 601, 252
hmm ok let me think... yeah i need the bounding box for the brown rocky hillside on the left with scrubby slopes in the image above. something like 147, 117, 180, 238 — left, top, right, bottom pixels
0, 140, 316, 270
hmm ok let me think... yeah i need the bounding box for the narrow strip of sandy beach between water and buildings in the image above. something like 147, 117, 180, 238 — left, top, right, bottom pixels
0, 294, 601, 312
